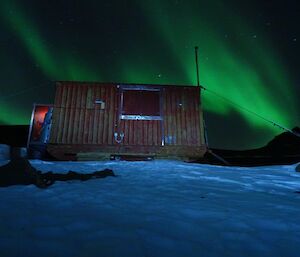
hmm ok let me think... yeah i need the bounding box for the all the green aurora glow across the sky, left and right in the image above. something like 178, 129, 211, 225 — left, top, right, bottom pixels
0, 0, 299, 148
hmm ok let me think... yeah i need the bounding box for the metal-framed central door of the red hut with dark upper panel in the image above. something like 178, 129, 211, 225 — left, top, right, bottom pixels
115, 86, 164, 147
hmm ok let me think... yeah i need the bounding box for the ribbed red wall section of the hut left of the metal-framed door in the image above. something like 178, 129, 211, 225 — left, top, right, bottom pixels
50, 82, 118, 145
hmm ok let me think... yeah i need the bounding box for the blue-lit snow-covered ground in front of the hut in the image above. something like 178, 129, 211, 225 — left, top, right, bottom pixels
0, 160, 300, 257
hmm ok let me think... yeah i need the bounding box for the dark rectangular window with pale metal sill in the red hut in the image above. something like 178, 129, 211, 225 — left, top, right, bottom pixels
122, 90, 160, 119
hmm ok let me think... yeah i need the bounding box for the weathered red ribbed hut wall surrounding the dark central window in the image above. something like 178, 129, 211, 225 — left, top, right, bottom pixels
50, 82, 204, 149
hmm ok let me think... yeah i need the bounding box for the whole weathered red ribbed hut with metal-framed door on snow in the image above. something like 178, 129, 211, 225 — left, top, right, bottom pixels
40, 82, 206, 160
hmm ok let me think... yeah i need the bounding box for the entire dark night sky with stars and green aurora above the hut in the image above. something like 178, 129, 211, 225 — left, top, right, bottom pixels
0, 0, 300, 149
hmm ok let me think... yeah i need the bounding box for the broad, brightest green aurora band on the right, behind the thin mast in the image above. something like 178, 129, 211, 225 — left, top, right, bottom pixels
138, 1, 296, 134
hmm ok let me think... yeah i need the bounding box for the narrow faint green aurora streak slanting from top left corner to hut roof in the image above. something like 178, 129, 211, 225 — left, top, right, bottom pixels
1, 1, 100, 81
